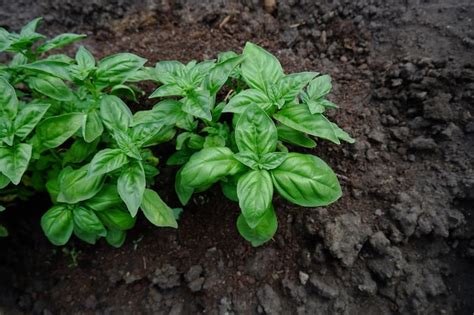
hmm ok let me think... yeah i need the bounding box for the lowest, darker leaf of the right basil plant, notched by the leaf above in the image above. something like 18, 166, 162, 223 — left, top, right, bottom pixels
237, 206, 278, 247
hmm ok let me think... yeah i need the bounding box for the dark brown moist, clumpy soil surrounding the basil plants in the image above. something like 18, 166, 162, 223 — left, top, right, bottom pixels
0, 0, 474, 314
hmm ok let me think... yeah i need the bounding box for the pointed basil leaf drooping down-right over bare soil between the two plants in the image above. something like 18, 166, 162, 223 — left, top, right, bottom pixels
140, 189, 178, 229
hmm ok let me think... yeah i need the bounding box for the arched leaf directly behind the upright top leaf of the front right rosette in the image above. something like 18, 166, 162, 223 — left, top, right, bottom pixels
223, 89, 273, 114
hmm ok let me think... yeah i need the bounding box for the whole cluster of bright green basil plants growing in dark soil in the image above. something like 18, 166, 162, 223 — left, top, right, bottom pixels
0, 19, 354, 247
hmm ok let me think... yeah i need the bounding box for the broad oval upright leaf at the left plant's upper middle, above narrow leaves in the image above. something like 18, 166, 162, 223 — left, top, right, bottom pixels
100, 95, 132, 132
